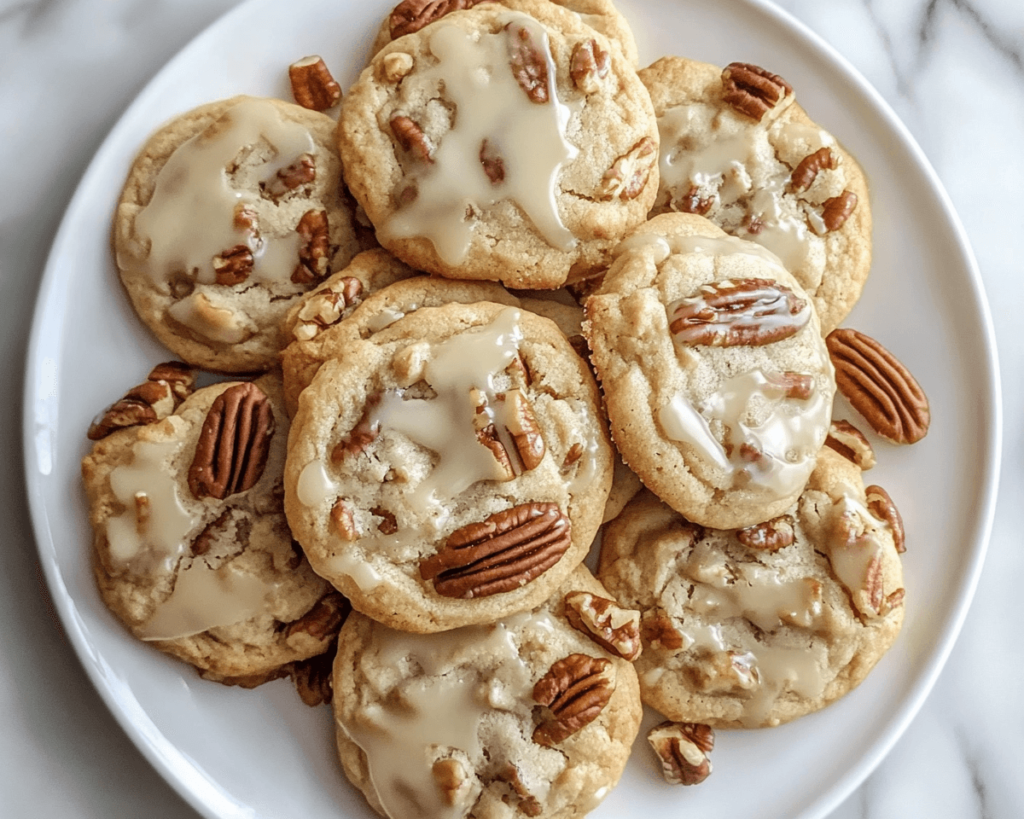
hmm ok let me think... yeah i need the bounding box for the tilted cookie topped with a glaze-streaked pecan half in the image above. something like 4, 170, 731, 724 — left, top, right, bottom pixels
584, 213, 836, 528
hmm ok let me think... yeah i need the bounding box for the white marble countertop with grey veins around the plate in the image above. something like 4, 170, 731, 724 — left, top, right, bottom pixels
0, 0, 1024, 819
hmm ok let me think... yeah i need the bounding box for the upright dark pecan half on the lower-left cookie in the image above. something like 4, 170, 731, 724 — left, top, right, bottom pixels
188, 382, 274, 501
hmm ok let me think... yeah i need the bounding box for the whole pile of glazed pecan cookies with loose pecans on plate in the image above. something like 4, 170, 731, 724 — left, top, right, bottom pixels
77, 0, 929, 819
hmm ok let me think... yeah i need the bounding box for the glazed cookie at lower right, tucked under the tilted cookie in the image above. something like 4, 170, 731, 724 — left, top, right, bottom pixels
598, 448, 904, 728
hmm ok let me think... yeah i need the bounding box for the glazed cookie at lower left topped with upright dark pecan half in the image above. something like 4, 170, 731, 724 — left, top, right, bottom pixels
82, 376, 347, 686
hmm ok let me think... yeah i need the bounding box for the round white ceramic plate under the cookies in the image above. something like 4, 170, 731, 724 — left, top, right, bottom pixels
25, 0, 999, 819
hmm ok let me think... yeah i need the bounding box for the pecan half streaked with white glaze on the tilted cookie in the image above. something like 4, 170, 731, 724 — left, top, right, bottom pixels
669, 278, 811, 347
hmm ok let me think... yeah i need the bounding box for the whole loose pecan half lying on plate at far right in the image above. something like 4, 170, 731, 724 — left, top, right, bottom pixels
825, 329, 931, 443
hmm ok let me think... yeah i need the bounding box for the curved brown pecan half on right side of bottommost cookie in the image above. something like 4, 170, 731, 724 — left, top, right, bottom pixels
534, 654, 615, 747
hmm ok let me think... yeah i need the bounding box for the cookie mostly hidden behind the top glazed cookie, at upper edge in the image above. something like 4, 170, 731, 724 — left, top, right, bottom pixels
372, 0, 639, 66
